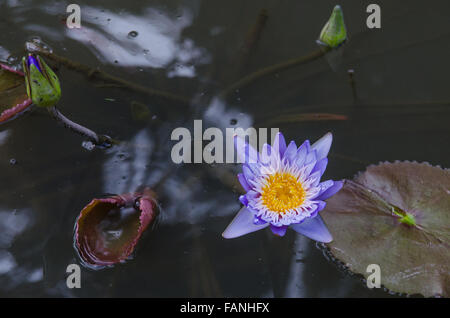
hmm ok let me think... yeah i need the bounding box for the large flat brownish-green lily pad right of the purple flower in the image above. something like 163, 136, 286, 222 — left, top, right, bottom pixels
321, 162, 450, 297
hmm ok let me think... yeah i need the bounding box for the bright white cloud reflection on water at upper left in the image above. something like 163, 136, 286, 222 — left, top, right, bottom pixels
65, 7, 210, 77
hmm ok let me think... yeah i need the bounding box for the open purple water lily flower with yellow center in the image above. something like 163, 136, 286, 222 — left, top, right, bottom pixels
222, 133, 342, 243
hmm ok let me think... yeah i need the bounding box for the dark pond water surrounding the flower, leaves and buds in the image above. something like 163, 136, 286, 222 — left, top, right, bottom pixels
0, 0, 450, 297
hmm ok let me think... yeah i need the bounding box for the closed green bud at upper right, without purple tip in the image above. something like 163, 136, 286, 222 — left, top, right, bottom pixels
317, 5, 347, 48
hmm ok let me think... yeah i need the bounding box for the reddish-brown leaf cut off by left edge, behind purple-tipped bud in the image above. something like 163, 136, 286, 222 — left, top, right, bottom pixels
0, 63, 31, 124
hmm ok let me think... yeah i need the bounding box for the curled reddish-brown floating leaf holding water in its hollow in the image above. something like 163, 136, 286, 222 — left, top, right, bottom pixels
75, 189, 157, 267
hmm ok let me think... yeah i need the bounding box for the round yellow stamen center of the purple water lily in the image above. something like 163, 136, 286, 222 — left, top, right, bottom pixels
261, 172, 306, 213
